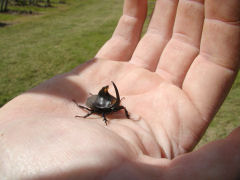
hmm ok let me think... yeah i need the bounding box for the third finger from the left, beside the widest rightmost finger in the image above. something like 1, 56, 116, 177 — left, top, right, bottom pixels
156, 0, 204, 87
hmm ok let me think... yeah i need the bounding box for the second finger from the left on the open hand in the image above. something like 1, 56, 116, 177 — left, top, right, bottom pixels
130, 0, 178, 71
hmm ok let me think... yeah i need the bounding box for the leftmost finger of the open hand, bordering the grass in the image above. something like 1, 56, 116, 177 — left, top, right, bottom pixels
96, 0, 147, 61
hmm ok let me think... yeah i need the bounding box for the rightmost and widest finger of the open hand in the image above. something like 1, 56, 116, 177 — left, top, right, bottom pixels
183, 0, 240, 128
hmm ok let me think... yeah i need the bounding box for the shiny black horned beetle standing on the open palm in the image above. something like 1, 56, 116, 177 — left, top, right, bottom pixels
74, 82, 129, 125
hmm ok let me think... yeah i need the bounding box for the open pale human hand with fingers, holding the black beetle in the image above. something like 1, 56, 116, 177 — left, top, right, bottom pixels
0, 0, 240, 180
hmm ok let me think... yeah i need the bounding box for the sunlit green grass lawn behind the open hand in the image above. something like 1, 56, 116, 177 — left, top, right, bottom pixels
0, 0, 240, 145
